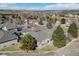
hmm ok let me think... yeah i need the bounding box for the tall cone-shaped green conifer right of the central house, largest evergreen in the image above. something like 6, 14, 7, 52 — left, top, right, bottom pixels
52, 26, 66, 48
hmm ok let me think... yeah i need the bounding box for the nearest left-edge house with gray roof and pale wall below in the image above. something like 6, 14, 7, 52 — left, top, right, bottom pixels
0, 30, 18, 48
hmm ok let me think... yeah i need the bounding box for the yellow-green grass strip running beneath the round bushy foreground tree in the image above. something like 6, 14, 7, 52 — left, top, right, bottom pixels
0, 44, 58, 55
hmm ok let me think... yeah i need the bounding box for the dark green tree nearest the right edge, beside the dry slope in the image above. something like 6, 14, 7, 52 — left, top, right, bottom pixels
68, 23, 78, 38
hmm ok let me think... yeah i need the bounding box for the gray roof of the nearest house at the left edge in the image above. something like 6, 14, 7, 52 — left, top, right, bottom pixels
0, 30, 17, 44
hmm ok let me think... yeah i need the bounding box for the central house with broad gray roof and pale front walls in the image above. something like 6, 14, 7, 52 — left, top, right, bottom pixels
22, 23, 52, 47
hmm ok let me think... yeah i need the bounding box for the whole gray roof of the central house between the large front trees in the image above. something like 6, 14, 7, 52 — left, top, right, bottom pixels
23, 27, 53, 42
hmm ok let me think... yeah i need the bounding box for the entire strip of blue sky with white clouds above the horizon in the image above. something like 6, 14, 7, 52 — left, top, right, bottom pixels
0, 3, 79, 10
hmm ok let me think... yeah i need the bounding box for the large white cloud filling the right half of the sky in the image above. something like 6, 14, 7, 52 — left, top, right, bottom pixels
41, 3, 79, 10
